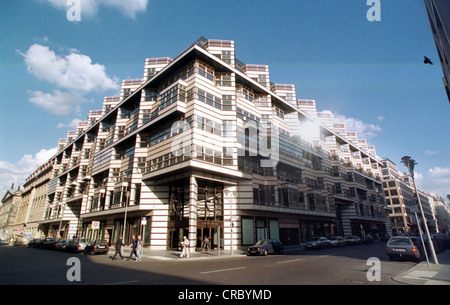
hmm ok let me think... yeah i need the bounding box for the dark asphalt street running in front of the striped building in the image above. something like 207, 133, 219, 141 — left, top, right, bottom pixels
0, 242, 415, 285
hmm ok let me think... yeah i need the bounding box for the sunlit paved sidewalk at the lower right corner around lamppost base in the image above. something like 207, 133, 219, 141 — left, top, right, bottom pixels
392, 249, 450, 285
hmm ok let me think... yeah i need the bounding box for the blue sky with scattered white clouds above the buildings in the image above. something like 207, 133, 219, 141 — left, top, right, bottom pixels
0, 0, 450, 197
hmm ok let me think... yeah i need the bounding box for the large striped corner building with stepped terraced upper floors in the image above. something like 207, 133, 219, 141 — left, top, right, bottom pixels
3, 37, 391, 250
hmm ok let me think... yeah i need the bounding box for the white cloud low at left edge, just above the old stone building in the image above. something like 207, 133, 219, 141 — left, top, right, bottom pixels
0, 147, 58, 197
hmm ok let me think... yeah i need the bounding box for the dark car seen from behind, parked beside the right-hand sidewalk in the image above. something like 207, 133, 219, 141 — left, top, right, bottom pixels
386, 236, 424, 261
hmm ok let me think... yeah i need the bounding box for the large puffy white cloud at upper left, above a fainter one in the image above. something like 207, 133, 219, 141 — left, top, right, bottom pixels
22, 43, 119, 92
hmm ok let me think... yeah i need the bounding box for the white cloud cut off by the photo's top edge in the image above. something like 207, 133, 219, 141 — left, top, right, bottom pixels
39, 0, 149, 20
